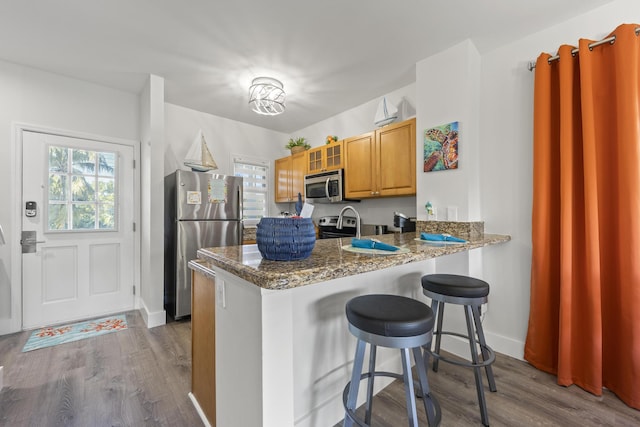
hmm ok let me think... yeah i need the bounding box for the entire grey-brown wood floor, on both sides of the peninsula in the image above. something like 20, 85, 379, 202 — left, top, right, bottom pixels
0, 311, 640, 427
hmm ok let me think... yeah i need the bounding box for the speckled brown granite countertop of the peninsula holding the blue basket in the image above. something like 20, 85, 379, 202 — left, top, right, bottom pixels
198, 233, 511, 290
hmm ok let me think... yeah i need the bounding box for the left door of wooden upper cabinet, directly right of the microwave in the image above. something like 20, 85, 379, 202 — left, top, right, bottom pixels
344, 132, 377, 199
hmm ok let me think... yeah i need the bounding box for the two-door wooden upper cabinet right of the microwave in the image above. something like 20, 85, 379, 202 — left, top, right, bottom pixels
344, 118, 416, 199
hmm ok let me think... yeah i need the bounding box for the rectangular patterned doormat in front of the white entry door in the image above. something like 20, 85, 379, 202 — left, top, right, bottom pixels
22, 314, 127, 353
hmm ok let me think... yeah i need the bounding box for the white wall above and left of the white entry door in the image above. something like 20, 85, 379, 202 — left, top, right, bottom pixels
0, 61, 138, 334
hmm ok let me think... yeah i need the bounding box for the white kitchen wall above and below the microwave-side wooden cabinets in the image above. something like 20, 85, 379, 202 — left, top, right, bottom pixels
292, 83, 416, 228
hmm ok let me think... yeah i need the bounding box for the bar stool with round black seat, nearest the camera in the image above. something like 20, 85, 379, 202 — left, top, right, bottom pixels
342, 295, 441, 427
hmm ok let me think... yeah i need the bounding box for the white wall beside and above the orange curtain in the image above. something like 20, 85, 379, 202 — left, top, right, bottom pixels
478, 0, 640, 357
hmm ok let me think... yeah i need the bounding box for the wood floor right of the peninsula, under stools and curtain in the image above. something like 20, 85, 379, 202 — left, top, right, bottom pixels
335, 354, 640, 427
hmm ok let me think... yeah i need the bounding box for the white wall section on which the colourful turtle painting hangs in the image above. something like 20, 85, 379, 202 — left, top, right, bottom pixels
416, 41, 482, 221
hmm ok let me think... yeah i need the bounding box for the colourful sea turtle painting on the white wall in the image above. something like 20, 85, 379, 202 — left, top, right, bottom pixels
424, 122, 458, 172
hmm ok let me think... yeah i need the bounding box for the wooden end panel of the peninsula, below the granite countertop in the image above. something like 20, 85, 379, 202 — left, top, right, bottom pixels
191, 272, 216, 425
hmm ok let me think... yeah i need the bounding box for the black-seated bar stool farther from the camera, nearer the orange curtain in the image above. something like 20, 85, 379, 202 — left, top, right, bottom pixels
422, 274, 497, 426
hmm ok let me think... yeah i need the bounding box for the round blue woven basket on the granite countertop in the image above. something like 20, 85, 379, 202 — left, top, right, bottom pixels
256, 218, 316, 261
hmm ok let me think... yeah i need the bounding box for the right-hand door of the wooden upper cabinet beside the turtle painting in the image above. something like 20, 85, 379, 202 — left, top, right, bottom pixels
375, 119, 416, 196
